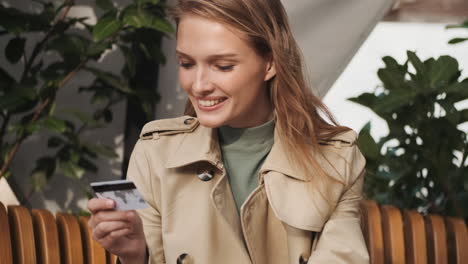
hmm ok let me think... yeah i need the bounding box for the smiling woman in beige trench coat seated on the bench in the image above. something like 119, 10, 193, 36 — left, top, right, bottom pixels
88, 0, 369, 264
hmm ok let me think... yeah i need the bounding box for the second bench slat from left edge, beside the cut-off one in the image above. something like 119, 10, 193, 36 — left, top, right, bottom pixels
8, 206, 36, 264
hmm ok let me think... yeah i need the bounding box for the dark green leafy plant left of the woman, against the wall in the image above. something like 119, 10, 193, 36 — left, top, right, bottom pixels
0, 0, 174, 204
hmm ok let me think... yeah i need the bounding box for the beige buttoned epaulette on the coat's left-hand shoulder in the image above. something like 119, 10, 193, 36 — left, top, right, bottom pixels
140, 116, 200, 140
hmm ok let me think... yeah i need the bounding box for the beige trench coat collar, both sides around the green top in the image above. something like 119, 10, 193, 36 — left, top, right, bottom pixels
166, 122, 309, 181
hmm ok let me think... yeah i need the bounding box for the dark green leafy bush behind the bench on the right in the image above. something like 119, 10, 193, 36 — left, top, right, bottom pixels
349, 51, 468, 218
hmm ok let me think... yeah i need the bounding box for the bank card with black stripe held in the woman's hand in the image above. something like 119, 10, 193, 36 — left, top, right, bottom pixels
91, 180, 148, 211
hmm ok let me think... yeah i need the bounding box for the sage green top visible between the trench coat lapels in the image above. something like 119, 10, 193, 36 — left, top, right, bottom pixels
218, 120, 275, 211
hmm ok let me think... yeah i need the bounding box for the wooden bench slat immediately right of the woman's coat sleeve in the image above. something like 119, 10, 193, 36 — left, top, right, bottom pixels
360, 200, 384, 264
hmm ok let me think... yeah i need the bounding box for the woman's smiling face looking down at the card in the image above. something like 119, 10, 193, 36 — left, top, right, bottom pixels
177, 15, 276, 127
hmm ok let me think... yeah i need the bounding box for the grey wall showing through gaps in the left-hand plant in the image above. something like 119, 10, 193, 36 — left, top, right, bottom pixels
0, 0, 125, 212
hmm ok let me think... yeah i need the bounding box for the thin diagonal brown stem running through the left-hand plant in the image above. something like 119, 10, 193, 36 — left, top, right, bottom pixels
0, 59, 88, 178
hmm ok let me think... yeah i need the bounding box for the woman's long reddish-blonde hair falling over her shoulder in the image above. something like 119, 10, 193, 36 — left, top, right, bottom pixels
171, 0, 349, 183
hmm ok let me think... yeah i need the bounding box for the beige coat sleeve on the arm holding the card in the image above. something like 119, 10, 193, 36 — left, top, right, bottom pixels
127, 140, 166, 264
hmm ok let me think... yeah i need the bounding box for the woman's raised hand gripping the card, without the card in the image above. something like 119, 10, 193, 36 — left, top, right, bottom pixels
88, 198, 146, 263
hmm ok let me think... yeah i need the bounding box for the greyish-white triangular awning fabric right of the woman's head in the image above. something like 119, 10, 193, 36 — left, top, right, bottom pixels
283, 0, 394, 97
